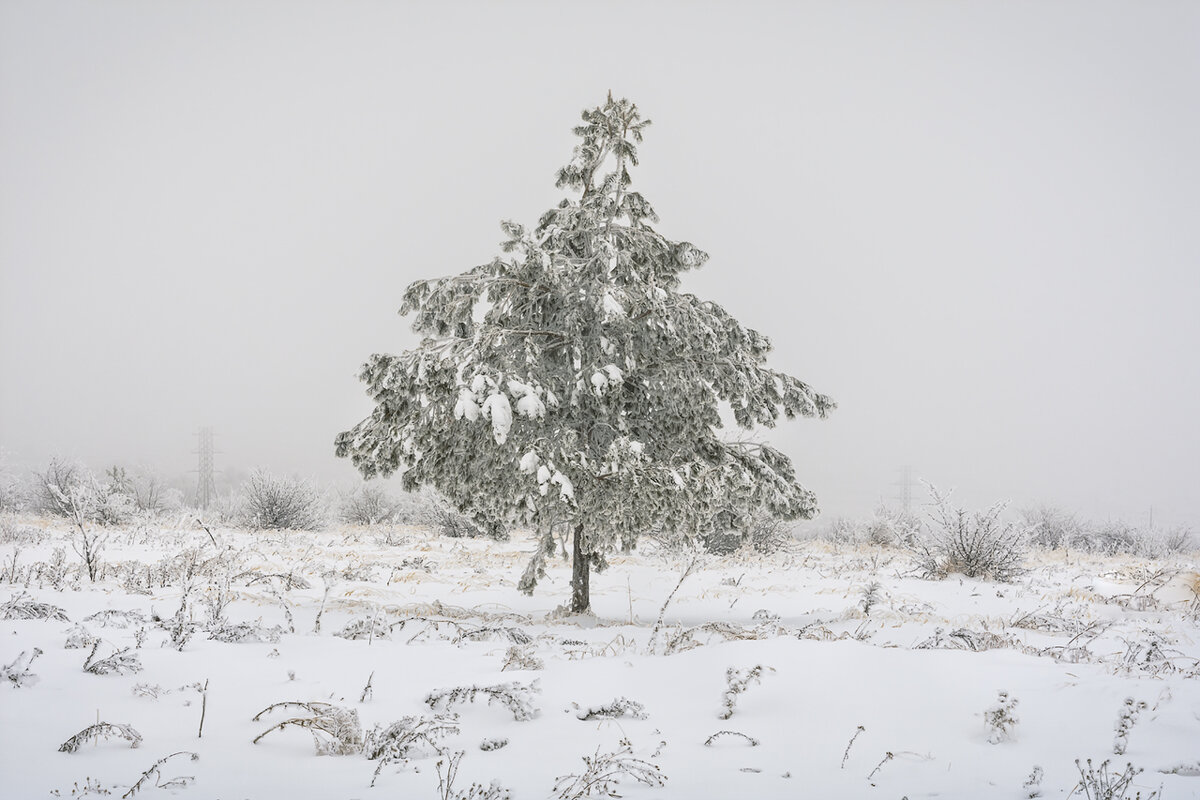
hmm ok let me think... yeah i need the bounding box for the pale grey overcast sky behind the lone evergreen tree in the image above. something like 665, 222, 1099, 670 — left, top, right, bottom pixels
0, 0, 1200, 525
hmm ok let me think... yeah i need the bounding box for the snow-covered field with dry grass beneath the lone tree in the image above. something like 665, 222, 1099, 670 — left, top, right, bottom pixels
0, 518, 1200, 800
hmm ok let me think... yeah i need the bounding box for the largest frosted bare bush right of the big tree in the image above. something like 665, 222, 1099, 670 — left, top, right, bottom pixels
911, 487, 1026, 581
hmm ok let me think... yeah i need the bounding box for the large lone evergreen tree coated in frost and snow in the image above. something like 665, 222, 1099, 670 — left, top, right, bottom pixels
336, 95, 834, 612
